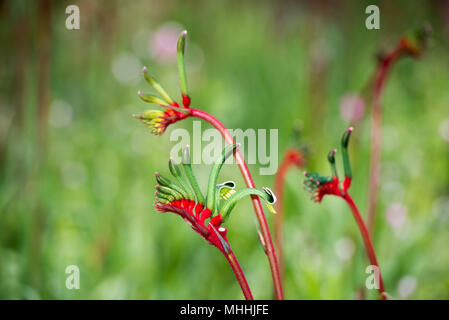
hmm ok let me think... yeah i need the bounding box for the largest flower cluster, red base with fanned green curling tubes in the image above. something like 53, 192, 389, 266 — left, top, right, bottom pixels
154, 144, 276, 254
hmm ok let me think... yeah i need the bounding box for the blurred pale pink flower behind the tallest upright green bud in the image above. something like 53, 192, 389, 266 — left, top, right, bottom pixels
148, 22, 183, 63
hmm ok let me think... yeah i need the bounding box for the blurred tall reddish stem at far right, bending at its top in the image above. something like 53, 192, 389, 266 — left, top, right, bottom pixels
367, 47, 402, 235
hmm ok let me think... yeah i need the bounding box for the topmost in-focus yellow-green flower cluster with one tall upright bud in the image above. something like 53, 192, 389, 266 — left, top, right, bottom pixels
133, 31, 191, 135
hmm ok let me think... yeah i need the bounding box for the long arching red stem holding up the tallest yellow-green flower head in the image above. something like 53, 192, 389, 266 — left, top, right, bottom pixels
190, 109, 284, 300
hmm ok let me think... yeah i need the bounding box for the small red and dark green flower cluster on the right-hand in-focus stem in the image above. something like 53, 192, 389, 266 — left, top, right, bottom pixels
304, 127, 353, 203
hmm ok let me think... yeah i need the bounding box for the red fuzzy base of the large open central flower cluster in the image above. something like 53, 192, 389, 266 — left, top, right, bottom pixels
154, 199, 229, 254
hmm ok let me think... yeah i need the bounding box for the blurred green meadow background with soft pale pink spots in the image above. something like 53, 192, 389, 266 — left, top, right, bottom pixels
0, 0, 449, 299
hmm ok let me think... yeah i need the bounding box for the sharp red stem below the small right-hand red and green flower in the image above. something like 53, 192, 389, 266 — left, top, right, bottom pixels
342, 193, 386, 300
